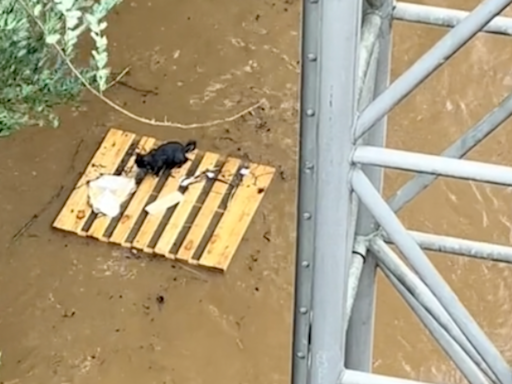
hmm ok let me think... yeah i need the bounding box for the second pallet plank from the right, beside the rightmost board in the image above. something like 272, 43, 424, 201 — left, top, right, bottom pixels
176, 157, 240, 263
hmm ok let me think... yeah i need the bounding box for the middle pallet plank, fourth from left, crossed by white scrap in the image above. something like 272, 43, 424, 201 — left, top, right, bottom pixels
132, 152, 196, 253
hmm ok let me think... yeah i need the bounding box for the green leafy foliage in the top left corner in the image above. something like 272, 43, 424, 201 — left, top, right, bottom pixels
0, 0, 122, 136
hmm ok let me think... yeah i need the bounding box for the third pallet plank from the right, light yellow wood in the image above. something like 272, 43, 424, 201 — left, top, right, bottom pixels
154, 152, 219, 258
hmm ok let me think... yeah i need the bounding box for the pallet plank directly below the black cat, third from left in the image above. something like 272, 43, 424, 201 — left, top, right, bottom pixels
108, 138, 158, 246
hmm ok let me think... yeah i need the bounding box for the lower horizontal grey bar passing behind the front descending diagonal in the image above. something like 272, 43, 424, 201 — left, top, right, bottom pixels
383, 231, 512, 264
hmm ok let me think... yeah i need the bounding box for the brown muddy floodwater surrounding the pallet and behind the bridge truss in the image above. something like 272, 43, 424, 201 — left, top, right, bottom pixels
0, 0, 512, 384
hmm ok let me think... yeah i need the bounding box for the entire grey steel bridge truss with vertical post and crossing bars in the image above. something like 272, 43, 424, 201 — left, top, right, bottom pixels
293, 0, 512, 384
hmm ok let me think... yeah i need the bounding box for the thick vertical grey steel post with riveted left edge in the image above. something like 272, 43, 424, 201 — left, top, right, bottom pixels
293, 0, 363, 384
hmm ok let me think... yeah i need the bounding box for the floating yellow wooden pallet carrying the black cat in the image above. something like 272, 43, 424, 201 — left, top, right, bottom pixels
53, 129, 275, 271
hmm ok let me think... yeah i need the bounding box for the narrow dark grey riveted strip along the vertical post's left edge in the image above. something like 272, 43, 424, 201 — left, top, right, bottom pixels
292, 1, 320, 384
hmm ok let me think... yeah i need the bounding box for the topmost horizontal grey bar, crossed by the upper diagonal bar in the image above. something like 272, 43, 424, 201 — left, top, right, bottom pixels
393, 1, 512, 36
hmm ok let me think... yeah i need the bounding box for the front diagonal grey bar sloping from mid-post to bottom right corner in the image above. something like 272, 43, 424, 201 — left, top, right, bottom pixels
352, 169, 512, 384
